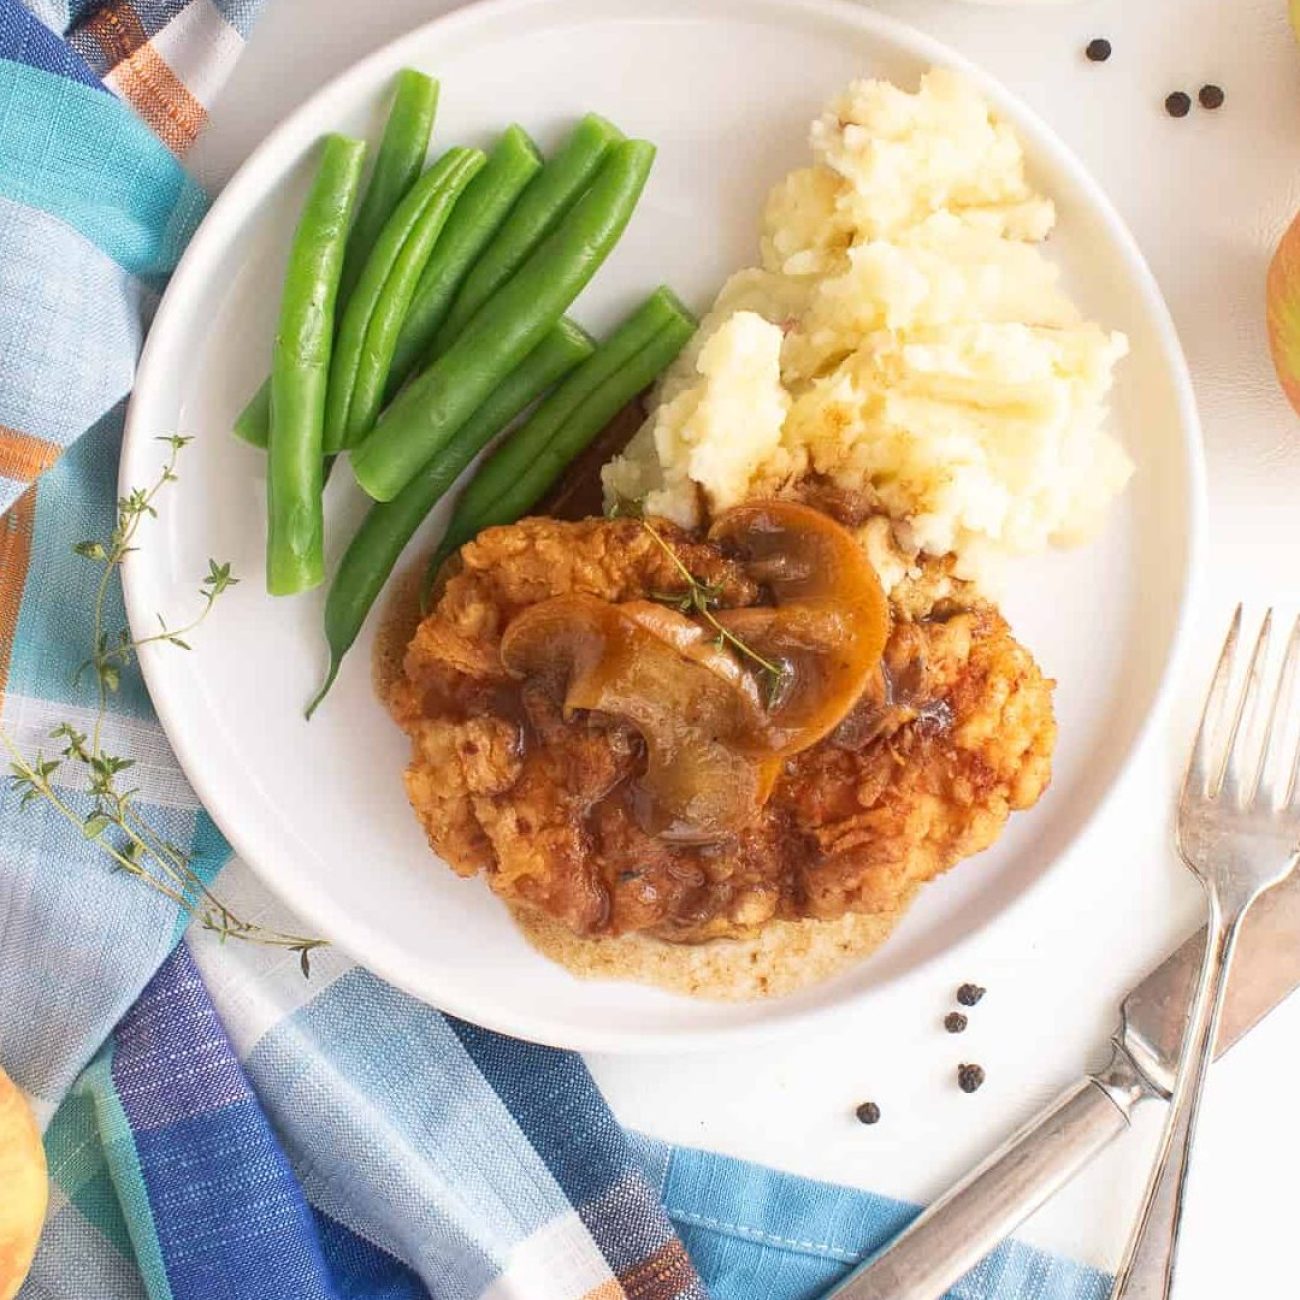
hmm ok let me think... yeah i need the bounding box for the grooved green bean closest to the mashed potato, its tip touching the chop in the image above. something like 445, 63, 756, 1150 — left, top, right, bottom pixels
420, 289, 696, 605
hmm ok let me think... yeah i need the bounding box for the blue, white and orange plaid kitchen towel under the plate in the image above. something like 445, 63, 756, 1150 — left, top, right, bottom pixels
0, 0, 1105, 1300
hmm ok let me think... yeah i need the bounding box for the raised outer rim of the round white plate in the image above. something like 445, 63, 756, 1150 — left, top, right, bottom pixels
118, 0, 1208, 1054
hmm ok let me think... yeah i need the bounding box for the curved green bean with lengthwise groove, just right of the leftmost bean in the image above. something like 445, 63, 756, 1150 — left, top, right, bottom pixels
325, 148, 486, 455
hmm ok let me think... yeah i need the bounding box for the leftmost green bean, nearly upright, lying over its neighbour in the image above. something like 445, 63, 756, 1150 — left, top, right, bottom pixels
267, 135, 365, 595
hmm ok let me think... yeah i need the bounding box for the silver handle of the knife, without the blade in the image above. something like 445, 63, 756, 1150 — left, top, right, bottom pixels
823, 1044, 1153, 1300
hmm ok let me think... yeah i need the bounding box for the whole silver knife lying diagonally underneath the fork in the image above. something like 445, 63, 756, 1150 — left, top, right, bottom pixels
823, 876, 1300, 1300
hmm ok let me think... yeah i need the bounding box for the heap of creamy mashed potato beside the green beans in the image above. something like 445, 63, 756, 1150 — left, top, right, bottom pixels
605, 69, 1132, 576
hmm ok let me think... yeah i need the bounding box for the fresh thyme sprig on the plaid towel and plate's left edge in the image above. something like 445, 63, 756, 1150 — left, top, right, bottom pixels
0, 436, 325, 975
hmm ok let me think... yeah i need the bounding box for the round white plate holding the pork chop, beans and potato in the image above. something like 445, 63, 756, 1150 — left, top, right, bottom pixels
121, 0, 1203, 1050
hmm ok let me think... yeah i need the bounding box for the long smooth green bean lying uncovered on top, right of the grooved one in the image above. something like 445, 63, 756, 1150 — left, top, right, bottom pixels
351, 140, 654, 501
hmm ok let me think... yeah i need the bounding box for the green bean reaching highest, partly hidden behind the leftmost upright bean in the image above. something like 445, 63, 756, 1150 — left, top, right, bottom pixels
234, 68, 438, 449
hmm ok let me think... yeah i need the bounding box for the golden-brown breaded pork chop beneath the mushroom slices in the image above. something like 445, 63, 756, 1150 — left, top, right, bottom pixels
389, 519, 1056, 943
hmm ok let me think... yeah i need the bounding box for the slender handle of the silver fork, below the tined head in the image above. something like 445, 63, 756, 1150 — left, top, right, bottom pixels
1110, 902, 1244, 1300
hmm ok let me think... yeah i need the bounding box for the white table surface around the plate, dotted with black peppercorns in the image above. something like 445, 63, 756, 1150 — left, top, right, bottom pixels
192, 0, 1300, 1300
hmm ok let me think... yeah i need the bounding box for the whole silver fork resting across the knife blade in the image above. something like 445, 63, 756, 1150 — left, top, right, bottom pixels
1110, 606, 1300, 1300
